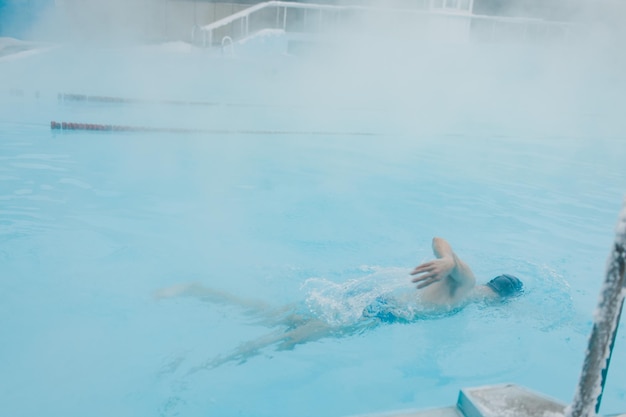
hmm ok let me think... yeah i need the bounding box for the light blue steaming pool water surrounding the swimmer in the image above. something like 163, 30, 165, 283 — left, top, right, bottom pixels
0, 35, 626, 416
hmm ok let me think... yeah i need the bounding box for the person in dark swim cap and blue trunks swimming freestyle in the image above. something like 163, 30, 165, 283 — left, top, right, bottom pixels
154, 237, 523, 372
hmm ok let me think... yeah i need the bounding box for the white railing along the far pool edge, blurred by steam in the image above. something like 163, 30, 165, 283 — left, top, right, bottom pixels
191, 0, 572, 47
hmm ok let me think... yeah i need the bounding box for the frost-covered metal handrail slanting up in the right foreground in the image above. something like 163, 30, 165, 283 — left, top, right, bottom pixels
566, 201, 626, 417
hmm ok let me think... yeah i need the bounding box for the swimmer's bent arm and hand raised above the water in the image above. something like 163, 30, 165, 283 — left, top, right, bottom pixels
411, 237, 476, 289
